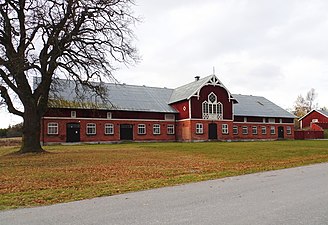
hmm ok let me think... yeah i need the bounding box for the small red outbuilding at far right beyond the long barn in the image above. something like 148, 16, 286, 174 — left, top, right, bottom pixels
299, 109, 328, 129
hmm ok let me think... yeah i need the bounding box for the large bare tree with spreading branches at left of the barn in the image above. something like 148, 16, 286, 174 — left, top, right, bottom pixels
0, 0, 138, 153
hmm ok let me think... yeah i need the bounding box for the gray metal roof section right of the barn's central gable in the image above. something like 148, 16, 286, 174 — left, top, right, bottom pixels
233, 94, 296, 118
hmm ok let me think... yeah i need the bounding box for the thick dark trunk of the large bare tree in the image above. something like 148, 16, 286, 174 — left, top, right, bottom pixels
19, 107, 45, 153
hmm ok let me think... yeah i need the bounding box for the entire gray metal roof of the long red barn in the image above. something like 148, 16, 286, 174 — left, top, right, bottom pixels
34, 75, 294, 118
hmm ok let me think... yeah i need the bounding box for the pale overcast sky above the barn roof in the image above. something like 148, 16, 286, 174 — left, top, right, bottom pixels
0, 0, 328, 127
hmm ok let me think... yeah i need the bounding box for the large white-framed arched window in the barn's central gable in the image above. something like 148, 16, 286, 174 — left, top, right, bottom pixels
202, 92, 223, 120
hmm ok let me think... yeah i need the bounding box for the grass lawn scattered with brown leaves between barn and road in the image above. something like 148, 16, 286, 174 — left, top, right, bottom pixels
0, 141, 328, 210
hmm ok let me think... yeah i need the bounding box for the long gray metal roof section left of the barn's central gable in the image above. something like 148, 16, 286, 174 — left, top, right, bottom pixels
43, 80, 177, 113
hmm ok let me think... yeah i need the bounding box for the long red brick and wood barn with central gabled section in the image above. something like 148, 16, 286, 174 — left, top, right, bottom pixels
35, 75, 295, 144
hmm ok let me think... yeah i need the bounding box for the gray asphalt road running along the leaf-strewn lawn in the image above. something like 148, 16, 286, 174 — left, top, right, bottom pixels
0, 163, 328, 225
